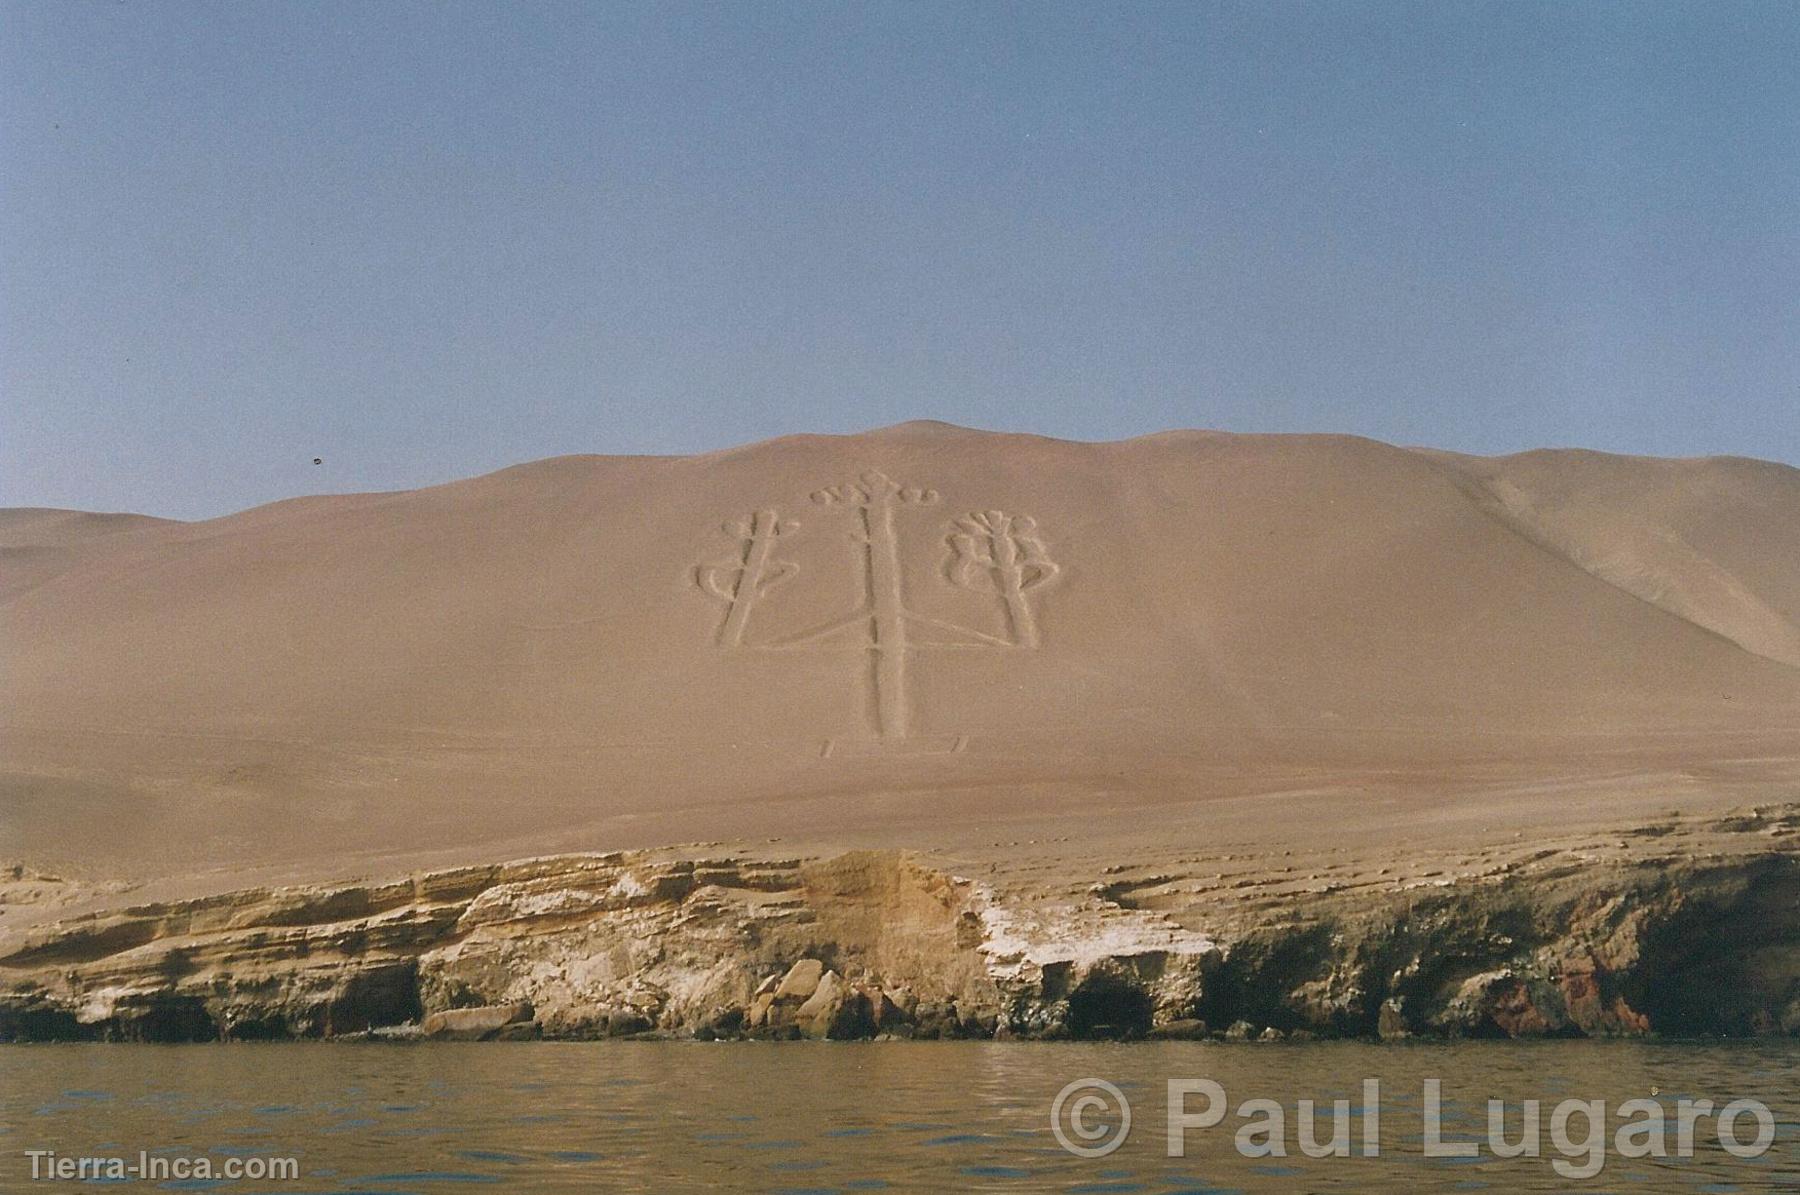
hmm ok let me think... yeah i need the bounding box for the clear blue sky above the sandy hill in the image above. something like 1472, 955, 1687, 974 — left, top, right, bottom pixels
0, 0, 1800, 518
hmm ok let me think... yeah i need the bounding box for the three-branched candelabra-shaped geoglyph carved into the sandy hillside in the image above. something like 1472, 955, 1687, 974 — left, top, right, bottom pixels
695, 470, 1060, 756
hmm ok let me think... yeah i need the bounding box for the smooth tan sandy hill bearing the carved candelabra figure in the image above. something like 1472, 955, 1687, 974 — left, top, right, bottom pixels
0, 425, 1800, 887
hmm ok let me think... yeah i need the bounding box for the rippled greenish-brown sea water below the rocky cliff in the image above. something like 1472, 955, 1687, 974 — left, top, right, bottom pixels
0, 1042, 1800, 1195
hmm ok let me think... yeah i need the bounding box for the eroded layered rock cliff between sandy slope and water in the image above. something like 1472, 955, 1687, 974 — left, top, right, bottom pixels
0, 804, 1800, 1040
